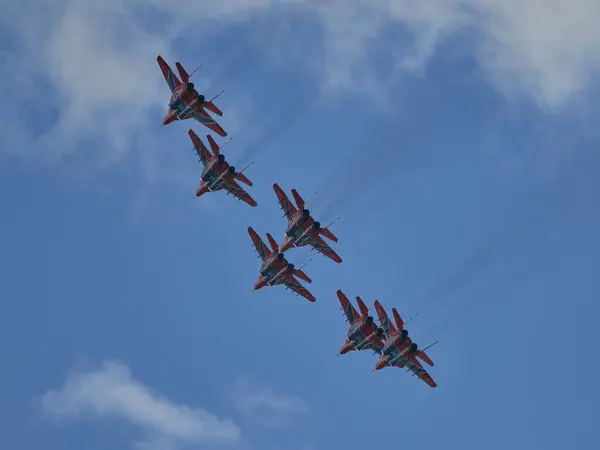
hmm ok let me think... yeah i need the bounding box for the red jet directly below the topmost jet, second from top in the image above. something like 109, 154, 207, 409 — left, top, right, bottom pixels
188, 129, 257, 206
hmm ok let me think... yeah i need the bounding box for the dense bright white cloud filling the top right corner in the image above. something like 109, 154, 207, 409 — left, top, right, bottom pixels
471, 0, 600, 107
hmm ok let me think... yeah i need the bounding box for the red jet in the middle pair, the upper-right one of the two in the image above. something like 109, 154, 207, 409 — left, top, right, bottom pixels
273, 183, 342, 263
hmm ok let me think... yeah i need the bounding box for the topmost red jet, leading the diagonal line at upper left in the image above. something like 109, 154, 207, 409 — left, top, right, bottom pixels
156, 55, 227, 137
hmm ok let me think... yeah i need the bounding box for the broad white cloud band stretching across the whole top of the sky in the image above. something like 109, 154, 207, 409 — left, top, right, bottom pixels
0, 0, 600, 172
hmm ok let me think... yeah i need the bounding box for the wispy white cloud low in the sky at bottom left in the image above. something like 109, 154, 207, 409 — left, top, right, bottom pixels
42, 362, 241, 449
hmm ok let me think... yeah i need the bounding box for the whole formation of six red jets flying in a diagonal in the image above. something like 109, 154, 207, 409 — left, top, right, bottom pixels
157, 55, 437, 387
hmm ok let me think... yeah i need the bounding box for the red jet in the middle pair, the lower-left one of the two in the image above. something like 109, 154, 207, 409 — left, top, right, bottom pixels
248, 227, 317, 302
